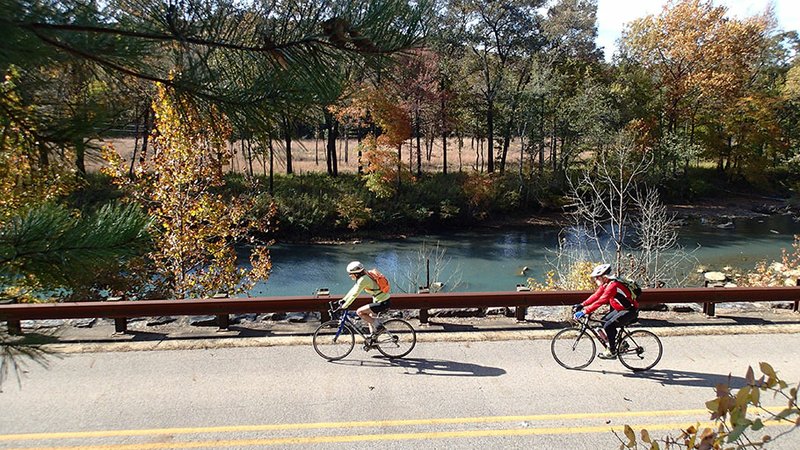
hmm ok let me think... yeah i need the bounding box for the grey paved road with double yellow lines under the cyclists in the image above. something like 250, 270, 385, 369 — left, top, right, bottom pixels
0, 334, 800, 449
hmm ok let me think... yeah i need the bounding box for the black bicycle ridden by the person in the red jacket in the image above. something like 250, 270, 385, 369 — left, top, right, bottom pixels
550, 315, 664, 372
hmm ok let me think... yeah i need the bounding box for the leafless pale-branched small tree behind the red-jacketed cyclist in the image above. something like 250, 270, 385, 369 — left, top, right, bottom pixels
550, 132, 696, 287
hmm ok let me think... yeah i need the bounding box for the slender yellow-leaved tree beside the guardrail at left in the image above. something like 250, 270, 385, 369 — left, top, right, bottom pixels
106, 86, 274, 298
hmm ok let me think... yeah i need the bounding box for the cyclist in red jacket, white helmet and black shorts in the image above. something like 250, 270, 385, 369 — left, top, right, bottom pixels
573, 264, 639, 359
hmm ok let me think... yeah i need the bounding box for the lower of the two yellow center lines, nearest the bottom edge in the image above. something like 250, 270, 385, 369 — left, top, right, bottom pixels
4, 421, 785, 450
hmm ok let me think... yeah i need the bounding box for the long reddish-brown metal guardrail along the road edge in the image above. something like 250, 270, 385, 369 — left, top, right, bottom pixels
0, 280, 800, 334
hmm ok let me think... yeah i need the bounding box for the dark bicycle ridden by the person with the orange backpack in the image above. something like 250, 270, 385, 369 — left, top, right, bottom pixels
312, 302, 417, 361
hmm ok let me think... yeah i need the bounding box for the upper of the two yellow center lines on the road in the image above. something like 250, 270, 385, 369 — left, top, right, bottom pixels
0, 409, 708, 442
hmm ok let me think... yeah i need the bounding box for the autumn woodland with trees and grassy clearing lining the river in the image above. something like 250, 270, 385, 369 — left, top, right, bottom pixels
0, 0, 800, 301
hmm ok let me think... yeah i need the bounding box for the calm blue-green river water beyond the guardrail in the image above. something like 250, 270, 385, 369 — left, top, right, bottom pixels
251, 216, 800, 296
